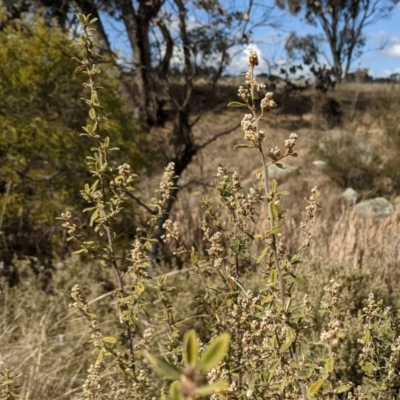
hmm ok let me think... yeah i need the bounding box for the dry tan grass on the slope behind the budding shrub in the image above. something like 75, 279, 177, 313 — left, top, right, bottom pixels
152, 84, 400, 290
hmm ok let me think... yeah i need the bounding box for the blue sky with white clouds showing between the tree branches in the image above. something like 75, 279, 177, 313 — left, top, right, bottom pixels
103, 0, 400, 77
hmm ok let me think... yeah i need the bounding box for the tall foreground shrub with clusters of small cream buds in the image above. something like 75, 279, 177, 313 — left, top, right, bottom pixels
1, 15, 400, 400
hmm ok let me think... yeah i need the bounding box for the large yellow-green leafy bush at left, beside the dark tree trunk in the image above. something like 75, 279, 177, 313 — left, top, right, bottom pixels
0, 14, 145, 277
